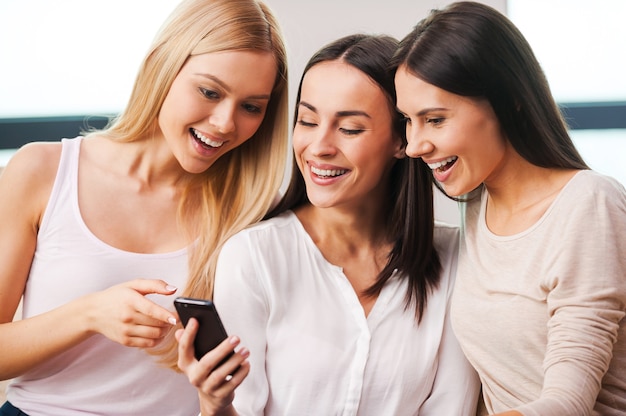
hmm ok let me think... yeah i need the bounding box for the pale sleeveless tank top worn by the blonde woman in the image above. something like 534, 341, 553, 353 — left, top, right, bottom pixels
7, 137, 199, 416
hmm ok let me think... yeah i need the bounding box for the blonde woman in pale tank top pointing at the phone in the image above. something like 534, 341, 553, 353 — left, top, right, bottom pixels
0, 0, 288, 416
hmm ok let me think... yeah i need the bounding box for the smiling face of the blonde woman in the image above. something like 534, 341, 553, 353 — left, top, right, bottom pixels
158, 50, 277, 173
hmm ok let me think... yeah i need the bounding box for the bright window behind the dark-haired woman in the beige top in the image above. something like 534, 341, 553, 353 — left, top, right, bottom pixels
507, 0, 626, 185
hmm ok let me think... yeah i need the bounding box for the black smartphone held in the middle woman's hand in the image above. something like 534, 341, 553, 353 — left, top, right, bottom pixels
174, 297, 233, 366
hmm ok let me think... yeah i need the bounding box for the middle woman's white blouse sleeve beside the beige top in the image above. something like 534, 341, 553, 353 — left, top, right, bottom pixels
419, 224, 480, 416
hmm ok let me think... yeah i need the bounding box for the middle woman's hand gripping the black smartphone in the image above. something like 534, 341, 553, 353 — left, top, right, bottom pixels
176, 318, 250, 416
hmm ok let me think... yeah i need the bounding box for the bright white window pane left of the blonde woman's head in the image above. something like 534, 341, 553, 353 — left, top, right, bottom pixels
0, 0, 180, 118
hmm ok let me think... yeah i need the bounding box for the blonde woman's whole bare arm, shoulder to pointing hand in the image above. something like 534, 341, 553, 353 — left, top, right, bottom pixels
0, 143, 175, 379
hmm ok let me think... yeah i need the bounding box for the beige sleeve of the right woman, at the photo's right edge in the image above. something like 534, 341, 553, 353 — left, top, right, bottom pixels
516, 176, 626, 416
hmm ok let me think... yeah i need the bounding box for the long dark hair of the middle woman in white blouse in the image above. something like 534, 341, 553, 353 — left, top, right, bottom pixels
267, 34, 441, 322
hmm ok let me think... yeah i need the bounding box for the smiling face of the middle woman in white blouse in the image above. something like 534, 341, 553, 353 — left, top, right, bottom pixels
293, 61, 404, 207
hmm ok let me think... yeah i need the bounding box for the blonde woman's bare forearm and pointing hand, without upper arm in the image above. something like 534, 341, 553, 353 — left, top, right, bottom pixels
0, 279, 176, 379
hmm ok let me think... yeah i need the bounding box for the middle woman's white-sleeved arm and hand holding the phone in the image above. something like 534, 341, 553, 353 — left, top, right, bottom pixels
179, 234, 268, 416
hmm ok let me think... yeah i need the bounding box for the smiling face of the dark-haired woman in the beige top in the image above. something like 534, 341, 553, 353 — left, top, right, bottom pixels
395, 66, 510, 196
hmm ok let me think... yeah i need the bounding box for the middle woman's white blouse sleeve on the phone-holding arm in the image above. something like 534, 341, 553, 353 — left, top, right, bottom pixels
213, 232, 269, 416
